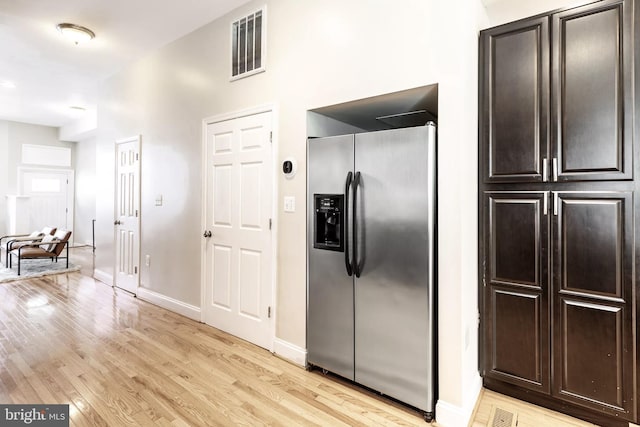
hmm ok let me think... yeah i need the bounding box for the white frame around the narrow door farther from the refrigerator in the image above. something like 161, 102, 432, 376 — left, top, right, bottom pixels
112, 134, 142, 295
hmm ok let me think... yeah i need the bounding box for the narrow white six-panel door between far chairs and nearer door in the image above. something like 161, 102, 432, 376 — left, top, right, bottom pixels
114, 137, 140, 294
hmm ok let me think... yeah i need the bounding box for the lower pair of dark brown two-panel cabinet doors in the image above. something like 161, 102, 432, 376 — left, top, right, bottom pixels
482, 191, 635, 420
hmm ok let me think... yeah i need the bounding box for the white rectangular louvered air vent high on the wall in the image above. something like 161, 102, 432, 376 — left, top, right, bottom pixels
231, 6, 266, 80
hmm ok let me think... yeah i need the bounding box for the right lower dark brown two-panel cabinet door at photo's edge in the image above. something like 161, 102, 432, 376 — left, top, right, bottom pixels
552, 191, 635, 420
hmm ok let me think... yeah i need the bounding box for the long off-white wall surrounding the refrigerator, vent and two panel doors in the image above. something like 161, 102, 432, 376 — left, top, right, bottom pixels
96, 0, 486, 426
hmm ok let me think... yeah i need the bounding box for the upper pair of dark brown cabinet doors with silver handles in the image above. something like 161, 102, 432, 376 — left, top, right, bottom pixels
480, 1, 633, 183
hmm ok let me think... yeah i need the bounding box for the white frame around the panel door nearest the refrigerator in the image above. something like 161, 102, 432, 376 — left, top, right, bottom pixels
200, 104, 279, 352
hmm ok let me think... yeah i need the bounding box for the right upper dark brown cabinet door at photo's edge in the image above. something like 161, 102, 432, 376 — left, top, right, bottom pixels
551, 1, 633, 181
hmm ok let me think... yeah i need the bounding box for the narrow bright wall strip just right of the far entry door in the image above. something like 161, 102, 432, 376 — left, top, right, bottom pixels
73, 137, 96, 245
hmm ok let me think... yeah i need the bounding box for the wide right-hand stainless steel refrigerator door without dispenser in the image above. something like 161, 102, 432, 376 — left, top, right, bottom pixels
354, 125, 435, 412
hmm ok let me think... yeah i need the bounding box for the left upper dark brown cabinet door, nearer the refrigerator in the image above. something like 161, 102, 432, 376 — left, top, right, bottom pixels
480, 17, 549, 182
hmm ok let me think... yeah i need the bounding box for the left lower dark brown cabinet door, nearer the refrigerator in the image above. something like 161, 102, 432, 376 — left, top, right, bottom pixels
483, 191, 550, 393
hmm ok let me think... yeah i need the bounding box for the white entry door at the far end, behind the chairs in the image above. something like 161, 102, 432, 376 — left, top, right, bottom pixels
18, 168, 74, 240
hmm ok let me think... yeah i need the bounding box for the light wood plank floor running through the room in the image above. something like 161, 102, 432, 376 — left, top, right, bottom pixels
0, 248, 620, 427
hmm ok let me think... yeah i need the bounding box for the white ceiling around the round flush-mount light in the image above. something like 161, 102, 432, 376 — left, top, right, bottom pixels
0, 0, 249, 127
